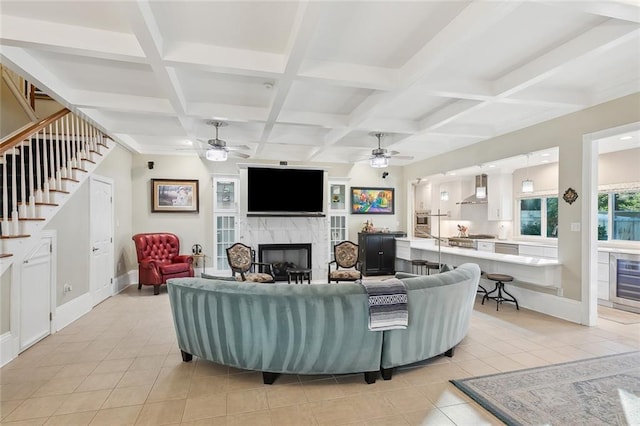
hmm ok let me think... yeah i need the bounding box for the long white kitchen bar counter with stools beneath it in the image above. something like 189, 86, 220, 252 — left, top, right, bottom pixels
396, 238, 562, 296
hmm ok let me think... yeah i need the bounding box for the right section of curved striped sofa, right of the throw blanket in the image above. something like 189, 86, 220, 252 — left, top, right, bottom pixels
381, 263, 480, 368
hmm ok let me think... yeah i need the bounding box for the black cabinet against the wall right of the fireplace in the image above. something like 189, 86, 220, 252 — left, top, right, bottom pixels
358, 232, 406, 276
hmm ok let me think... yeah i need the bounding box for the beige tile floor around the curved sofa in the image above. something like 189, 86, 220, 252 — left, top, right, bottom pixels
0, 286, 640, 426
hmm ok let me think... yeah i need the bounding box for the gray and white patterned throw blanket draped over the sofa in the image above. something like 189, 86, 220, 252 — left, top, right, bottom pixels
360, 278, 409, 331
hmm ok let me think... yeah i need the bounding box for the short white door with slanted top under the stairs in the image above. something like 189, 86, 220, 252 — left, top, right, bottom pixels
20, 236, 53, 352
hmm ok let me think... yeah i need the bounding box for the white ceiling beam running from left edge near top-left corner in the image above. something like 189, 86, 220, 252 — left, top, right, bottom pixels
0, 15, 144, 63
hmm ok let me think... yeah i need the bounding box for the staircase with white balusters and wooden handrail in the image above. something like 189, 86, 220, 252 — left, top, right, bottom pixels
0, 109, 113, 274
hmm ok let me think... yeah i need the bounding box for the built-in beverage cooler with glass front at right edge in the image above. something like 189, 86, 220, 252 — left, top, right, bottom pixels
609, 253, 640, 313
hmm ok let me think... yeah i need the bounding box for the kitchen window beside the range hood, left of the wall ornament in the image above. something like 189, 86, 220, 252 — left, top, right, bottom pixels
520, 197, 558, 238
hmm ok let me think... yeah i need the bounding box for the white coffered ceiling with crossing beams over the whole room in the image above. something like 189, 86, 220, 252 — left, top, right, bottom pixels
0, 0, 640, 165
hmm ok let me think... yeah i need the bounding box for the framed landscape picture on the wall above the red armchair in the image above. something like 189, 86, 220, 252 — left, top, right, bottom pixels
151, 179, 200, 213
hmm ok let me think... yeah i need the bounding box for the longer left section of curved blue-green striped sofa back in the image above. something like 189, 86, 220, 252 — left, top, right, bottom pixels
167, 278, 382, 374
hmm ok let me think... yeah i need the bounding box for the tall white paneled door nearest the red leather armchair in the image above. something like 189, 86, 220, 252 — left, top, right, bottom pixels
89, 176, 114, 306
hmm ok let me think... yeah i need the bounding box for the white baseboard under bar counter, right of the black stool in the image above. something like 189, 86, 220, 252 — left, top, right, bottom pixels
500, 285, 582, 324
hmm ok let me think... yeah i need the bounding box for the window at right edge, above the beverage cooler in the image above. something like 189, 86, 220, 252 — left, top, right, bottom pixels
598, 191, 640, 241
